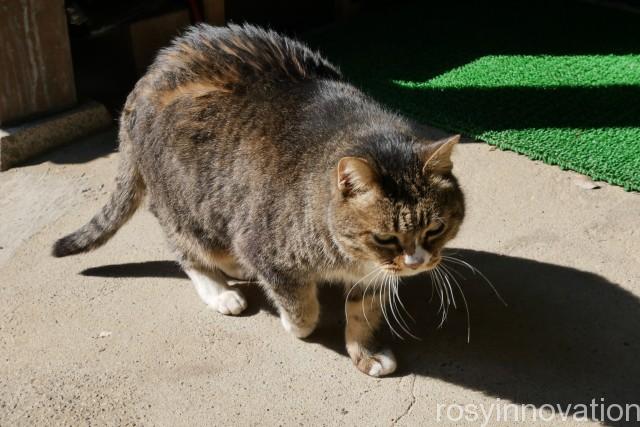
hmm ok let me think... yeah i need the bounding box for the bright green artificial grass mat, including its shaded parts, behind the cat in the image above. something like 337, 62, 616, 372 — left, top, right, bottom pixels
309, 2, 640, 191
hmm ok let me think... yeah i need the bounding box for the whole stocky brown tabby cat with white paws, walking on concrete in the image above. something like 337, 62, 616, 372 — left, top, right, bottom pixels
53, 24, 464, 376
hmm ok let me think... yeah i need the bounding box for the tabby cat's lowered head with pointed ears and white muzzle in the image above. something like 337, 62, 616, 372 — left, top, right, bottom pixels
331, 135, 464, 276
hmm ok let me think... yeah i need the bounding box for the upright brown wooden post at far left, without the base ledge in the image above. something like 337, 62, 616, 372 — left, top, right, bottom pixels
0, 0, 76, 124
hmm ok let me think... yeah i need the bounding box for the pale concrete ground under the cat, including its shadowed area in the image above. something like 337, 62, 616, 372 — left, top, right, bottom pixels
0, 132, 640, 426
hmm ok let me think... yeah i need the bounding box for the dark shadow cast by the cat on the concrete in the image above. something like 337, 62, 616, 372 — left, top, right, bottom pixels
83, 250, 640, 425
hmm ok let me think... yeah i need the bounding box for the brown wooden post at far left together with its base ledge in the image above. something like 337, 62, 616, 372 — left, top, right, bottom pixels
0, 0, 112, 171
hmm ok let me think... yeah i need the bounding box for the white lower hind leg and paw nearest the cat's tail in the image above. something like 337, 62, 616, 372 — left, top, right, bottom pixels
185, 266, 247, 316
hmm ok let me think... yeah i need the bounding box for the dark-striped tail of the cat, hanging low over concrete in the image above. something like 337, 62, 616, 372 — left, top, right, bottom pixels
52, 156, 145, 257
